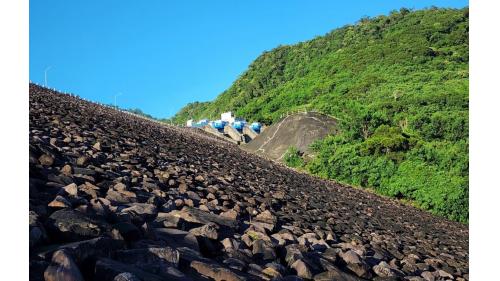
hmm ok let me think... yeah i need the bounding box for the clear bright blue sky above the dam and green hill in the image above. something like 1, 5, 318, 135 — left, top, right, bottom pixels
29, 0, 468, 118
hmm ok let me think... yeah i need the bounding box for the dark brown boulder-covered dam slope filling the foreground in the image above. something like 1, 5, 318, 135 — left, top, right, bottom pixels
29, 85, 468, 281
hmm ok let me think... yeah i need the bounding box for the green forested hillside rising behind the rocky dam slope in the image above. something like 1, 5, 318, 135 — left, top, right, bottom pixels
173, 8, 469, 222
